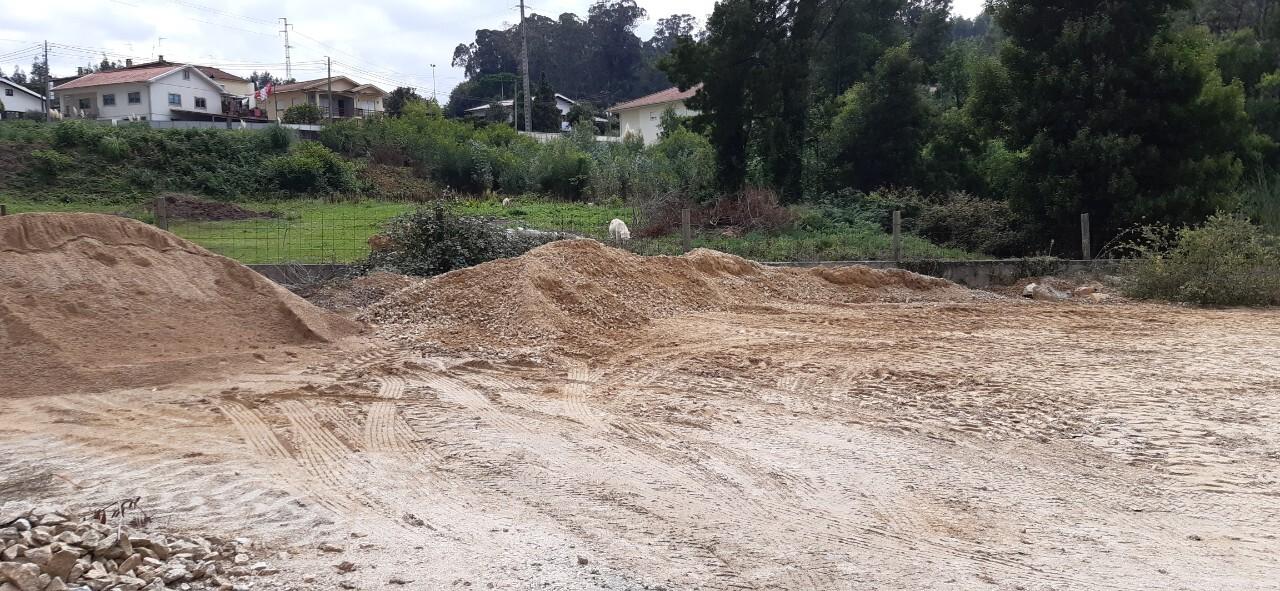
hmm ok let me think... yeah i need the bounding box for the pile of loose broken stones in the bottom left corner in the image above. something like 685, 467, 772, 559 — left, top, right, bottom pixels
0, 504, 264, 591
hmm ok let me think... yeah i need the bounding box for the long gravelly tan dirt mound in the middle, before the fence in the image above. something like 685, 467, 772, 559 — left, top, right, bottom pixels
366, 240, 997, 354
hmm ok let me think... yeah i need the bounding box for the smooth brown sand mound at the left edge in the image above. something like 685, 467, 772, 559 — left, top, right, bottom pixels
0, 214, 357, 395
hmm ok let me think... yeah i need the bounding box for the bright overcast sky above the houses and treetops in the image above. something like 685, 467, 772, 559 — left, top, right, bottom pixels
0, 0, 983, 101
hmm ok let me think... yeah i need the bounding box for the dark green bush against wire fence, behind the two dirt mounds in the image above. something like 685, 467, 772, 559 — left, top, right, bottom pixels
361, 205, 553, 276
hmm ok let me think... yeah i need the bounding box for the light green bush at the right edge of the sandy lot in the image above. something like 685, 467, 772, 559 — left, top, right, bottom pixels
1123, 214, 1280, 306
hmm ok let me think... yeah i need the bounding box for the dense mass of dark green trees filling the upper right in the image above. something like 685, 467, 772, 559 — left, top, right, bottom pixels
660, 0, 1280, 258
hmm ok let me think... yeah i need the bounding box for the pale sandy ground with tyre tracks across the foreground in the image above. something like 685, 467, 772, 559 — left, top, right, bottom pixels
0, 301, 1280, 590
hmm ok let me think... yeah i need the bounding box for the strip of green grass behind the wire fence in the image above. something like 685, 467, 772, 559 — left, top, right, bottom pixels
0, 197, 979, 264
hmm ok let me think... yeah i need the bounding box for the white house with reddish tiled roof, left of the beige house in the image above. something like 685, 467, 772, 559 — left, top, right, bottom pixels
54, 64, 224, 122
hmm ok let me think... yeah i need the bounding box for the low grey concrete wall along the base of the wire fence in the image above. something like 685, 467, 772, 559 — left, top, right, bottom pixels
248, 258, 1125, 288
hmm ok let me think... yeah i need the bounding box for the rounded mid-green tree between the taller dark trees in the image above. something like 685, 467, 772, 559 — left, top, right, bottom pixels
829, 45, 931, 191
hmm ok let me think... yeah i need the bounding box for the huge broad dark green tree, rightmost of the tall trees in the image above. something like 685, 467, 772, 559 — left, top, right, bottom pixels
993, 0, 1258, 246
